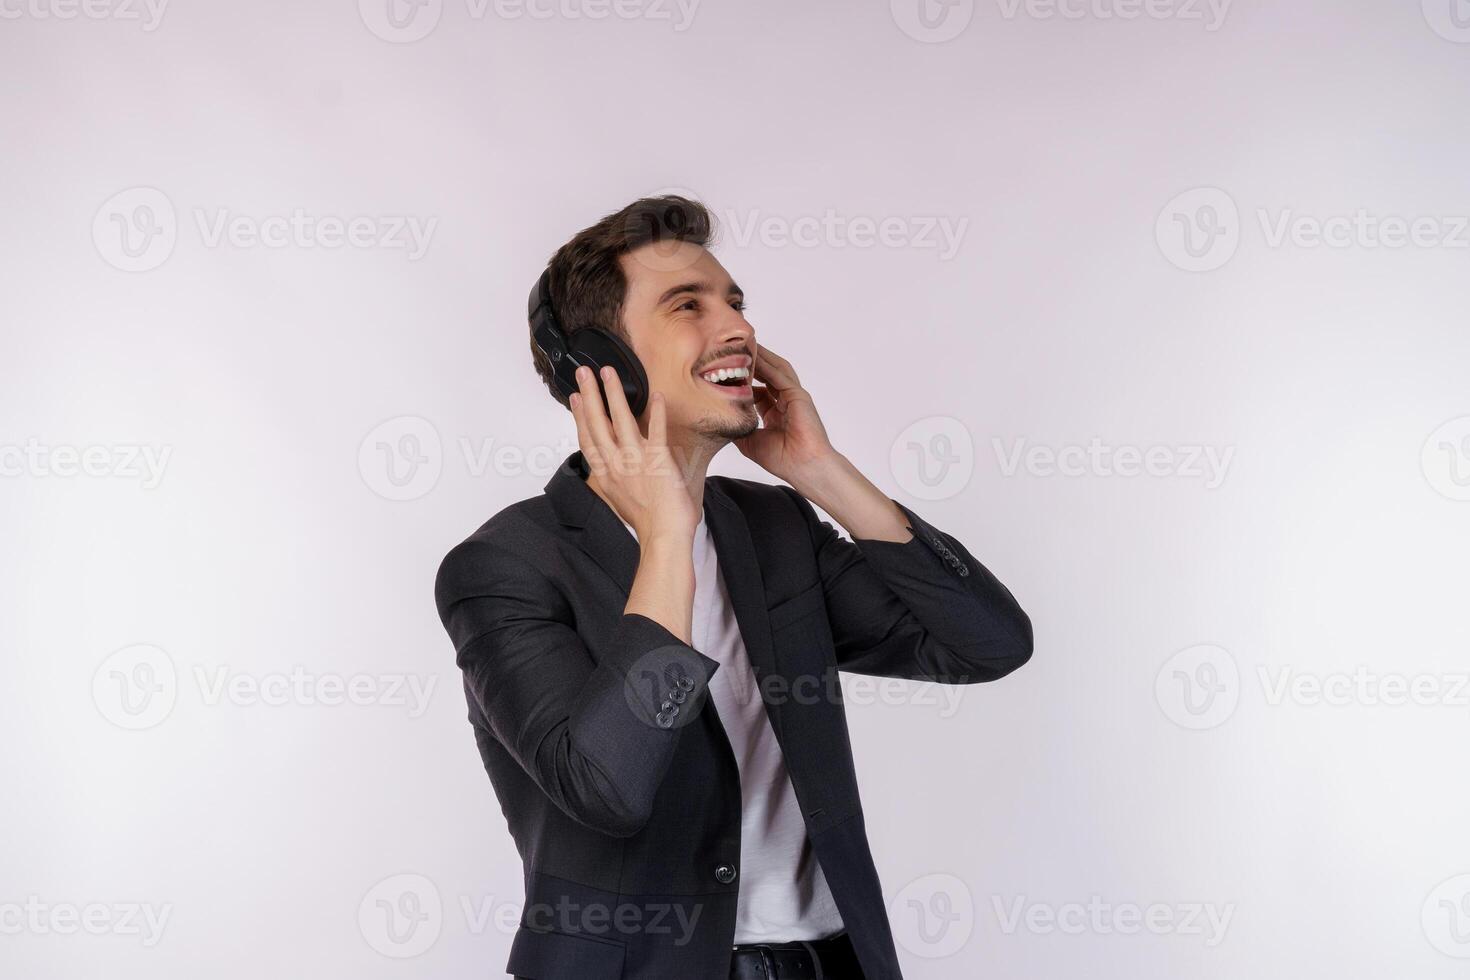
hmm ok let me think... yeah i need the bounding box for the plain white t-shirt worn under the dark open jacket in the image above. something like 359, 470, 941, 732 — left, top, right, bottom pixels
623, 514, 842, 943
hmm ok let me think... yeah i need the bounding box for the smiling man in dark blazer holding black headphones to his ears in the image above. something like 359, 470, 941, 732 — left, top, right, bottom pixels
435, 197, 1032, 980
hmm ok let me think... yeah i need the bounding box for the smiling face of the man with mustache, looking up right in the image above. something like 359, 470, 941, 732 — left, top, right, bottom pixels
619, 242, 760, 445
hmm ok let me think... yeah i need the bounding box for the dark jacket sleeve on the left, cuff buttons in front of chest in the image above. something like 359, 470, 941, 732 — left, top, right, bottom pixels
434, 539, 719, 837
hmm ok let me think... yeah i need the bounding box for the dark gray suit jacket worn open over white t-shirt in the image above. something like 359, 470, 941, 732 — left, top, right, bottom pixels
435, 453, 1032, 980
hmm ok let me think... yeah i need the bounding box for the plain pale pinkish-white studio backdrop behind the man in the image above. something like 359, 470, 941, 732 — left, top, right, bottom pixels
0, 0, 1470, 980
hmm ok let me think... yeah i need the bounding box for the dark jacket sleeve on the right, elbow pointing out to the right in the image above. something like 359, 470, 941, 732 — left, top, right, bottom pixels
782, 486, 1032, 685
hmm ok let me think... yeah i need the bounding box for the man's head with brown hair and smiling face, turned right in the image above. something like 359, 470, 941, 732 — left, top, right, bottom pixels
531, 195, 759, 444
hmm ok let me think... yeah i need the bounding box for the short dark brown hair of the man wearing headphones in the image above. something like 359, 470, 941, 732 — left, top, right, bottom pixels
528, 194, 714, 406
